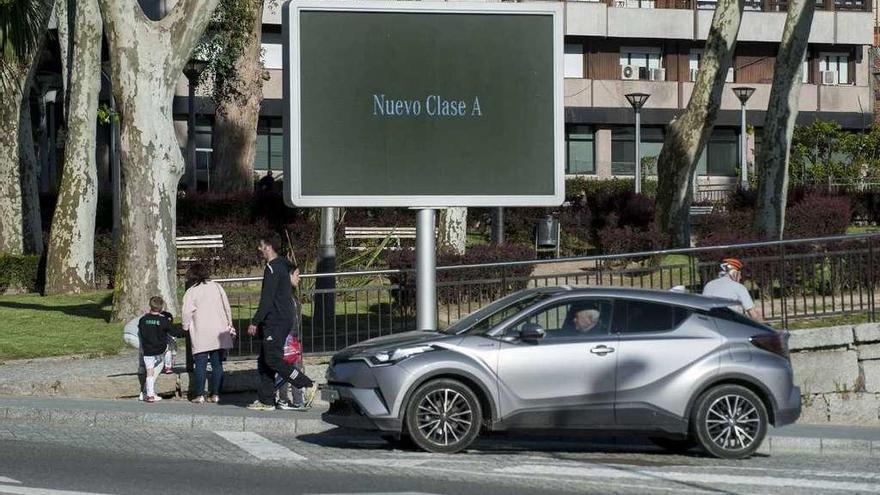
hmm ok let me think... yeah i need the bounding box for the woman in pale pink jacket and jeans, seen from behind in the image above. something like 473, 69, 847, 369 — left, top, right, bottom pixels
182, 263, 235, 404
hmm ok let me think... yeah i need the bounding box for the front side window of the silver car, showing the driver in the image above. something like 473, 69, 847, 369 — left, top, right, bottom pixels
507, 299, 614, 339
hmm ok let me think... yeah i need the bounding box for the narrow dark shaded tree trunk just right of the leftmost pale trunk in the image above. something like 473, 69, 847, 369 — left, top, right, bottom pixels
18, 86, 43, 255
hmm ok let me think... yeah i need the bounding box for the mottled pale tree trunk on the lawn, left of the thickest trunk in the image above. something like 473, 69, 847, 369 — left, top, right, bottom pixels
46, 0, 102, 294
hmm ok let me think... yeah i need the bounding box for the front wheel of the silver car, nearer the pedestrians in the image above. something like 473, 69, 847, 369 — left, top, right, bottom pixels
406, 379, 483, 454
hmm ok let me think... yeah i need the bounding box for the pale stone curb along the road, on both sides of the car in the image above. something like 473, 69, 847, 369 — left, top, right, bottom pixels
0, 406, 880, 458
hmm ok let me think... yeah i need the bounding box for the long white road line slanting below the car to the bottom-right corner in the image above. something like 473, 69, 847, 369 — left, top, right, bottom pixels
495, 464, 880, 493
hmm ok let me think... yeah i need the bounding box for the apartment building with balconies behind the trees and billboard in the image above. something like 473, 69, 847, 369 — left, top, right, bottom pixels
36, 0, 880, 194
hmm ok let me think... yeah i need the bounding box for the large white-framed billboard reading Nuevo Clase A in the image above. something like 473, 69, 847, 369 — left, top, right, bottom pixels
283, 2, 564, 207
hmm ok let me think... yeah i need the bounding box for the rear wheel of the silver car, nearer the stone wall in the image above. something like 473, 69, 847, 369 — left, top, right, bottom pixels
693, 385, 768, 459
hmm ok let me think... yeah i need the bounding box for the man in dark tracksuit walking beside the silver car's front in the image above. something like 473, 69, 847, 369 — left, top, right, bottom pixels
248, 236, 312, 411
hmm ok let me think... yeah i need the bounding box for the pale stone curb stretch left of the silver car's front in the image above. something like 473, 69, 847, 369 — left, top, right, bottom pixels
0, 407, 336, 435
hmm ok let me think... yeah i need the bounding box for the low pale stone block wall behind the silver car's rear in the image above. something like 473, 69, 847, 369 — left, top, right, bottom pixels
789, 323, 880, 426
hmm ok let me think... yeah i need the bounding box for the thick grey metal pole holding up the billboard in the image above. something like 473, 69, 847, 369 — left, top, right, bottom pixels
416, 208, 437, 330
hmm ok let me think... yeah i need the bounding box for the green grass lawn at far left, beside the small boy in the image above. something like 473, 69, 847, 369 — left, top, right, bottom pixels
0, 291, 124, 360
